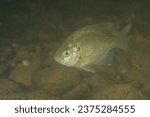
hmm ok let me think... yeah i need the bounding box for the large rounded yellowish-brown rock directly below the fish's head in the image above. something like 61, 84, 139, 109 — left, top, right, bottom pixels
32, 65, 81, 95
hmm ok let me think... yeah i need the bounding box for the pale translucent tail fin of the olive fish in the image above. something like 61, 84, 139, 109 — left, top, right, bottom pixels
118, 24, 131, 50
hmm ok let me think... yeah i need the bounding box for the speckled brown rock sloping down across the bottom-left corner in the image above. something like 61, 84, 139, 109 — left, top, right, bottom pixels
0, 78, 60, 100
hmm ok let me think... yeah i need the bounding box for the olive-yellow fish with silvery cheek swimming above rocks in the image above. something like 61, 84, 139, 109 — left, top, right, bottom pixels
54, 22, 131, 73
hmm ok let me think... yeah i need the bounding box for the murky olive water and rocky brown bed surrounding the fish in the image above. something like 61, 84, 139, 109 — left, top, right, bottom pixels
0, 0, 150, 100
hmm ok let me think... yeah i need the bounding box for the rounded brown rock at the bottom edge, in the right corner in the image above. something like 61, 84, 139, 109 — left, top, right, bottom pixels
97, 84, 145, 100
